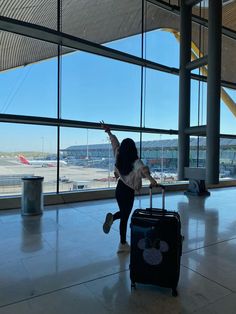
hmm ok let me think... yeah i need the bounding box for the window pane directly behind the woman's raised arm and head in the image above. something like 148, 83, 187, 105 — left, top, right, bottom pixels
60, 128, 139, 191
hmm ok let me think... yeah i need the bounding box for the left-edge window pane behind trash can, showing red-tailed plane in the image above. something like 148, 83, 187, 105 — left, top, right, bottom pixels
0, 123, 57, 196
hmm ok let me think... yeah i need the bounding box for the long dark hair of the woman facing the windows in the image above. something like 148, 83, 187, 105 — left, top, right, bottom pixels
116, 138, 138, 175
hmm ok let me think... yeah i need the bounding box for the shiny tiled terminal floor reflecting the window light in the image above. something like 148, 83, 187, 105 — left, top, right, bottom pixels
0, 188, 236, 314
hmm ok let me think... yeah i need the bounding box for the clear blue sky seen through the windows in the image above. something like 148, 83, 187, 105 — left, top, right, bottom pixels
0, 31, 236, 151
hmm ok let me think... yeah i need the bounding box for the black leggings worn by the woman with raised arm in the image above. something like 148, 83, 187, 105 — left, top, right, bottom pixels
113, 179, 134, 244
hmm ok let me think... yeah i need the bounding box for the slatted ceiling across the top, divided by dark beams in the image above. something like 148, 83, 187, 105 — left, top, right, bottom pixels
0, 0, 236, 83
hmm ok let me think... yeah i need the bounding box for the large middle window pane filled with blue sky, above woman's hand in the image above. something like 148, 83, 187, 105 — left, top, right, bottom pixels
61, 52, 141, 126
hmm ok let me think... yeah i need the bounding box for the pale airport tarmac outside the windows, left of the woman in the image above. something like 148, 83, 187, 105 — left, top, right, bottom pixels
0, 158, 116, 195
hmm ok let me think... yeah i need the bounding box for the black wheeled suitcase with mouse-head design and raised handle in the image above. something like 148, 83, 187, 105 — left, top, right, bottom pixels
130, 186, 182, 296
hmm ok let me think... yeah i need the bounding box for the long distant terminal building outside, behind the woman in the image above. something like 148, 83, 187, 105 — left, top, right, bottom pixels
61, 137, 236, 174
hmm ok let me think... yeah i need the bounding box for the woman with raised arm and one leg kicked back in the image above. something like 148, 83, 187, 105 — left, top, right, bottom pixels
101, 121, 158, 253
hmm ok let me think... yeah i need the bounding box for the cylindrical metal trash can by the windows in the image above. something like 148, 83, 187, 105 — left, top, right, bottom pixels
21, 176, 44, 216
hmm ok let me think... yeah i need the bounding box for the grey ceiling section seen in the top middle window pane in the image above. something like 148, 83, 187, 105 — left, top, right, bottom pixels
62, 0, 142, 44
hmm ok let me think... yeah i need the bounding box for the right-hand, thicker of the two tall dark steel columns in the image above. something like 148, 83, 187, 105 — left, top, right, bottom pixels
206, 0, 222, 184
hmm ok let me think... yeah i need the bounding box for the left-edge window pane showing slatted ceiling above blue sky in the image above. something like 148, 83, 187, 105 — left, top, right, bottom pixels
0, 35, 57, 117
